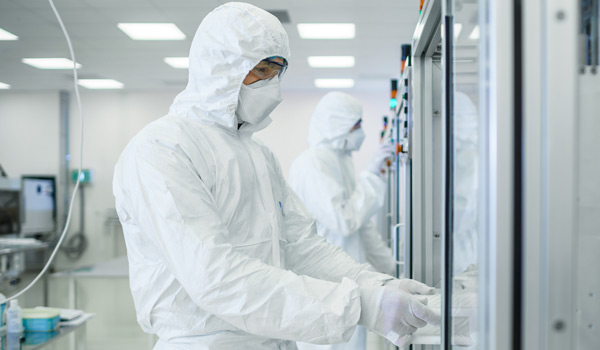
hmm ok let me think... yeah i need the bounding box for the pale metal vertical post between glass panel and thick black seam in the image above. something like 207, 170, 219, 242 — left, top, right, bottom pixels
479, 0, 516, 350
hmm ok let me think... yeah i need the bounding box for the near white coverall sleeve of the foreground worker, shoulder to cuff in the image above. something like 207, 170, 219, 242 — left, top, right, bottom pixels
119, 140, 360, 343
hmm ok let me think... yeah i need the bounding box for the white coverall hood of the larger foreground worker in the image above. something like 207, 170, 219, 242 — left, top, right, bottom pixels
169, 2, 290, 128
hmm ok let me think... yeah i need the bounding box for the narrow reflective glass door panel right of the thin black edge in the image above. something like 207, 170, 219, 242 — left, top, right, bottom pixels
442, 0, 483, 349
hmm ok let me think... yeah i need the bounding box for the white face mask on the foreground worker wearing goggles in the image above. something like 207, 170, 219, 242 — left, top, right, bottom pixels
235, 78, 282, 125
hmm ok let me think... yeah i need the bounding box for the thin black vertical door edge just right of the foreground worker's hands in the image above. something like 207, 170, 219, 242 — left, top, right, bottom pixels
441, 0, 454, 350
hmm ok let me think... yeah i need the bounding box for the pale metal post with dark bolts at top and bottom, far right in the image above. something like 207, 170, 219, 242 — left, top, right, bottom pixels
543, 0, 580, 350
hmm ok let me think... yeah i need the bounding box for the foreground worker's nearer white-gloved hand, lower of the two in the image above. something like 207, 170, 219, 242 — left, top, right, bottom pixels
358, 286, 440, 346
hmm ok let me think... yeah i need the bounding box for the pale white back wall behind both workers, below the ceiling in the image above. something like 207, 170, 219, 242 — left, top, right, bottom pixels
0, 90, 388, 268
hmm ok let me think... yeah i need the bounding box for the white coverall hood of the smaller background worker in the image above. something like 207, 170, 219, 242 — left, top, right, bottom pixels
308, 91, 362, 146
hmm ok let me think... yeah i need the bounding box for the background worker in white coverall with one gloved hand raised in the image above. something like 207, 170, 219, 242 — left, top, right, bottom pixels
289, 92, 396, 350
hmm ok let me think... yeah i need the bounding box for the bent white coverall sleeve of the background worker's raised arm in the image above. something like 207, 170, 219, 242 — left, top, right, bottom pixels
294, 159, 385, 236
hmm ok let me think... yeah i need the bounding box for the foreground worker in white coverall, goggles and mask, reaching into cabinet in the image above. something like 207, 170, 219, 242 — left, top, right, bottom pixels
113, 3, 439, 350
